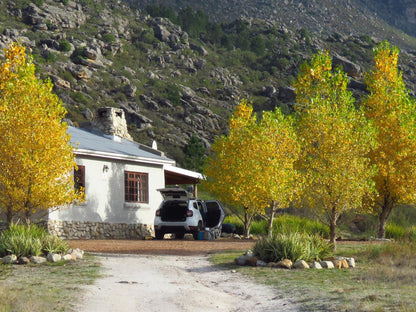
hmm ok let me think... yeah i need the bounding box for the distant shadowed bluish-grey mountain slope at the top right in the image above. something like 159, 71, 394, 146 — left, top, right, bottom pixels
131, 0, 416, 47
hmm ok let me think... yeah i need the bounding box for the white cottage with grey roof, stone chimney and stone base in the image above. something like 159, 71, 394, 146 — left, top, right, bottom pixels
47, 108, 202, 239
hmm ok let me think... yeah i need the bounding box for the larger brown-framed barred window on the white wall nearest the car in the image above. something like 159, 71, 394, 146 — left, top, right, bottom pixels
124, 171, 149, 203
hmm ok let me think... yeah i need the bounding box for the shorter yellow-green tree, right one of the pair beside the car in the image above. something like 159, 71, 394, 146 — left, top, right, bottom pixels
248, 108, 300, 237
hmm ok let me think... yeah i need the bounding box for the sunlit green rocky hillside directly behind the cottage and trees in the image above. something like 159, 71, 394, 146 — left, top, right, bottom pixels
0, 0, 416, 164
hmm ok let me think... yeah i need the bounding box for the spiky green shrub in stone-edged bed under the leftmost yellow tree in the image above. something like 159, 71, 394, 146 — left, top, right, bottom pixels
0, 223, 68, 257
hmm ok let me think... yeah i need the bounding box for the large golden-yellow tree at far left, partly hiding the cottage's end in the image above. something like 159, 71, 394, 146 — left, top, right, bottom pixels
0, 43, 82, 223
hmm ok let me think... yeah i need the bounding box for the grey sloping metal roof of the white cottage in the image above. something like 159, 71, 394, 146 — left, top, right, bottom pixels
68, 127, 174, 163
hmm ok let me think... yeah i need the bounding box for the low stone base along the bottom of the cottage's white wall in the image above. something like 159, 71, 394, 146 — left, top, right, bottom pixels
47, 220, 153, 239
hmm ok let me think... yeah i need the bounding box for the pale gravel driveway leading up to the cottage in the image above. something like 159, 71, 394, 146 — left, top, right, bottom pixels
78, 254, 297, 312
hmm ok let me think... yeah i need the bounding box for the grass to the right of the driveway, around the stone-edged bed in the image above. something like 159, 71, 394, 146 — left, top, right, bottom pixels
211, 243, 416, 311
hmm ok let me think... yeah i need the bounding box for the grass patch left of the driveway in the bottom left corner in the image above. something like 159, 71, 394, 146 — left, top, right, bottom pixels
0, 255, 100, 312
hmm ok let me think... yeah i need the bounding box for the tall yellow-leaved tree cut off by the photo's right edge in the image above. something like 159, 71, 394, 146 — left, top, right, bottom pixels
363, 41, 416, 238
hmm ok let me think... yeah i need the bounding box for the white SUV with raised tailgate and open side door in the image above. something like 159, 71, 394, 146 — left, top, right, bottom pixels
154, 187, 224, 239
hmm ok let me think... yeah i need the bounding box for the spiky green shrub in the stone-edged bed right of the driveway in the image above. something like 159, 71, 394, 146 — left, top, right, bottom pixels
253, 232, 333, 262
